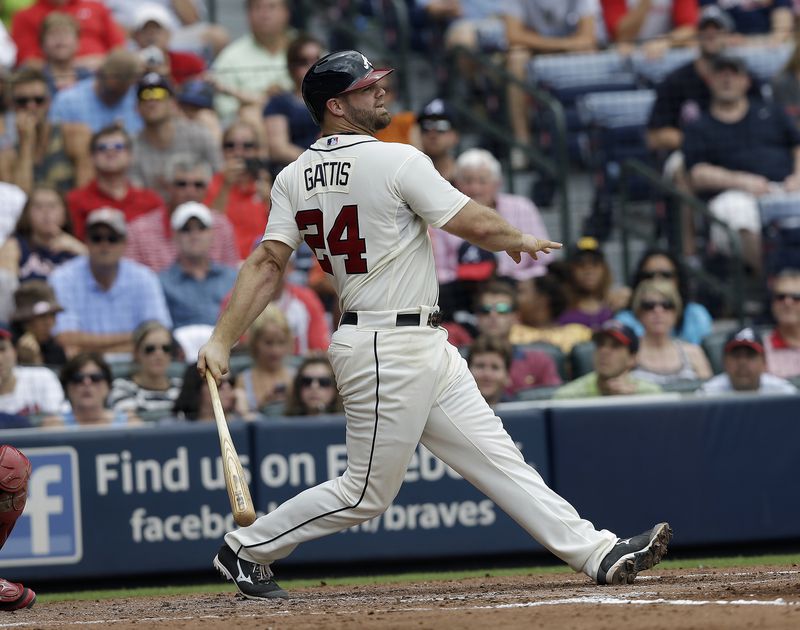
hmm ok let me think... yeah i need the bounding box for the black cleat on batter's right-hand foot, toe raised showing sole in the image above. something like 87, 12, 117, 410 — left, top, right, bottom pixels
597, 523, 672, 584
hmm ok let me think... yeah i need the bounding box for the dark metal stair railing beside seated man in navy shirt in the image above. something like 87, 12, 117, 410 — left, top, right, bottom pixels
620, 160, 745, 326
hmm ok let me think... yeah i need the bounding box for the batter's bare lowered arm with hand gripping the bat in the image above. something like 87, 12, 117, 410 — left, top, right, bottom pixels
197, 241, 292, 382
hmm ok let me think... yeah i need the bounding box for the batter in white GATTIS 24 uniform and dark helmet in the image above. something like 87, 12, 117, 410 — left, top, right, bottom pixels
198, 50, 671, 599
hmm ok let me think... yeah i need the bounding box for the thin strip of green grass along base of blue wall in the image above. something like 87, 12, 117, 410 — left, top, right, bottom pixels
37, 554, 800, 603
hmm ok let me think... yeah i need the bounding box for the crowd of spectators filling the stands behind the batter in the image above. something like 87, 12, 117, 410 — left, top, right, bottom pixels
0, 0, 800, 428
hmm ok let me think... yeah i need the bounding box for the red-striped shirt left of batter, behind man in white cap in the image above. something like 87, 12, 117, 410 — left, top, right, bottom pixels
125, 208, 240, 273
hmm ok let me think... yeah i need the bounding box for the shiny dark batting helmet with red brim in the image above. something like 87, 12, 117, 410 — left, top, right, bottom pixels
302, 50, 393, 125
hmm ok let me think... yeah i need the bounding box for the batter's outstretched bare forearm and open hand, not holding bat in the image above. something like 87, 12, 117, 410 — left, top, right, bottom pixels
442, 200, 562, 263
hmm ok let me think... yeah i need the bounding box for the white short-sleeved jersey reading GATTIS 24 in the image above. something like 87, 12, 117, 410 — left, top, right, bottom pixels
264, 134, 469, 311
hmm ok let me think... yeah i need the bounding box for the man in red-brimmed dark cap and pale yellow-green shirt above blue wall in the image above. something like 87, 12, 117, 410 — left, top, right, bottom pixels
553, 319, 661, 400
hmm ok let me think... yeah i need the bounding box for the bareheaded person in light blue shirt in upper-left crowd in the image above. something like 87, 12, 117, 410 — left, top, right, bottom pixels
50, 48, 142, 135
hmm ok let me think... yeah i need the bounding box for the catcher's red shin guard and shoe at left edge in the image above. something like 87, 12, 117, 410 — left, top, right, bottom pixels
0, 444, 36, 610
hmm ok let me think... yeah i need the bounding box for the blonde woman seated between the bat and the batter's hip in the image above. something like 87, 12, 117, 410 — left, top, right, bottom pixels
236, 305, 294, 417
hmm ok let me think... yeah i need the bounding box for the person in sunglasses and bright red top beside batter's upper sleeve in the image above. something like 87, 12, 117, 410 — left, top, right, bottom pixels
205, 121, 272, 259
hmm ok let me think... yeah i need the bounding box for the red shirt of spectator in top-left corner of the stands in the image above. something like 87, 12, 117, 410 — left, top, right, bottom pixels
11, 0, 125, 70
